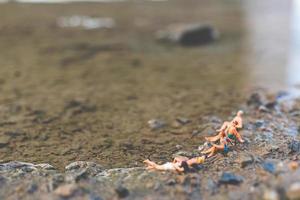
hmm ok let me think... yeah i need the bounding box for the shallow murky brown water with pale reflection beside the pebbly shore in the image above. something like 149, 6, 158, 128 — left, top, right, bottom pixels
0, 0, 300, 168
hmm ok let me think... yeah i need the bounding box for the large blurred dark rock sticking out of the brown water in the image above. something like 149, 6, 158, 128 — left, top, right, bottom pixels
156, 24, 219, 46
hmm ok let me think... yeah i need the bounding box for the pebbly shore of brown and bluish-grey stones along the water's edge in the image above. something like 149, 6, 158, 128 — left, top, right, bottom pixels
0, 93, 300, 200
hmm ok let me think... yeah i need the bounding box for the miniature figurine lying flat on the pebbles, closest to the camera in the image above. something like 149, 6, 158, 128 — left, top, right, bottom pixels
144, 156, 205, 172
